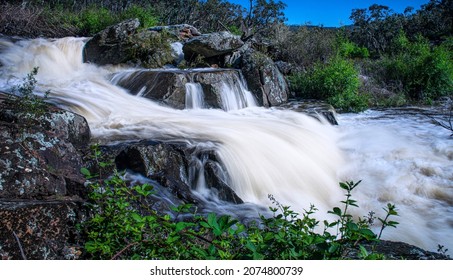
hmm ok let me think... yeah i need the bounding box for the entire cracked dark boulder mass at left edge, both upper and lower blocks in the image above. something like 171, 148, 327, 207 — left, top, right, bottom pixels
0, 93, 90, 259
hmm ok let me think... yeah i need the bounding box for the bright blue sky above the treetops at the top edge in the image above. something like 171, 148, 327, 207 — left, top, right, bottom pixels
228, 0, 429, 27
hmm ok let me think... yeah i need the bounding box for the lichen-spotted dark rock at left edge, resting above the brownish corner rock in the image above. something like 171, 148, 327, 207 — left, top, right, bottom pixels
0, 93, 90, 199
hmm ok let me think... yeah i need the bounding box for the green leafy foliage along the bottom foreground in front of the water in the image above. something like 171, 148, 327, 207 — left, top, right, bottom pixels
81, 146, 397, 259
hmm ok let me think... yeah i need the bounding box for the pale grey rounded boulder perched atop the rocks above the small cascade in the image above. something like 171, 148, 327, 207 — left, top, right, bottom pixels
183, 31, 244, 60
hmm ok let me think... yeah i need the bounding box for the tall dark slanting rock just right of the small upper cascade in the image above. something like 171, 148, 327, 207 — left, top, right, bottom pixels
241, 49, 289, 107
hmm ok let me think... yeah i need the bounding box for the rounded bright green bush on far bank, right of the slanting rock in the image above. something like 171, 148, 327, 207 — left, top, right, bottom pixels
290, 56, 368, 112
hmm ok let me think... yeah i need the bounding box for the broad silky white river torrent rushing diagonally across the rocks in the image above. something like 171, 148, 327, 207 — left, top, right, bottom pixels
0, 38, 453, 250
